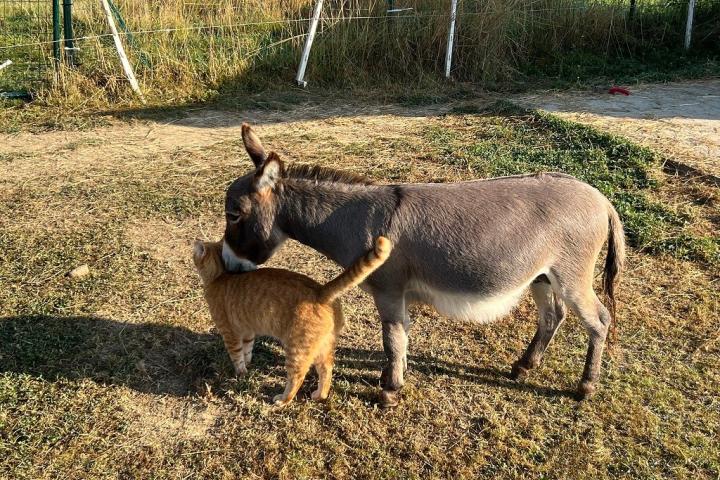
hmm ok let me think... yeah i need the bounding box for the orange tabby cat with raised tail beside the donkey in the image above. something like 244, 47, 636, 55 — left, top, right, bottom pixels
193, 237, 392, 405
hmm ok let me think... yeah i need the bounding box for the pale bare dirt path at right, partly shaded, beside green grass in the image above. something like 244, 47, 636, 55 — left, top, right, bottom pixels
519, 80, 720, 176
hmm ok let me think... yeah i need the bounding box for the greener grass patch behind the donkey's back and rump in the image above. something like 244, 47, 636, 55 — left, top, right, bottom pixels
426, 102, 720, 265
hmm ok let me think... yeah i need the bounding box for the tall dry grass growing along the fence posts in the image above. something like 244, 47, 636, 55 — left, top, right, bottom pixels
2, 0, 720, 103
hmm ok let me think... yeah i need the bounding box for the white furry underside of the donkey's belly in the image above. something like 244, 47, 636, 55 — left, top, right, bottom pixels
407, 279, 532, 323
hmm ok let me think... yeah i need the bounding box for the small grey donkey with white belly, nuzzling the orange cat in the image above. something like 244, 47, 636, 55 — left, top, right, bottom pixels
223, 124, 625, 406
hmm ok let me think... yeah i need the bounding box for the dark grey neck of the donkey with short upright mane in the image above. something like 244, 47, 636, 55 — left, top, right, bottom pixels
279, 180, 396, 267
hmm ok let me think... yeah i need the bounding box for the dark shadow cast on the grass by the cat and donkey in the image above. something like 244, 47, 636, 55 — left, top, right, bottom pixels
0, 315, 571, 401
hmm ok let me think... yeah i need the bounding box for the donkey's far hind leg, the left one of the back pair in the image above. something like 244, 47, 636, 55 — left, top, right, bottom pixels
510, 275, 565, 380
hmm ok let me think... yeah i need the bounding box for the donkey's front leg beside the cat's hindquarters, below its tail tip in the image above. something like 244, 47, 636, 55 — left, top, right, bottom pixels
375, 295, 407, 407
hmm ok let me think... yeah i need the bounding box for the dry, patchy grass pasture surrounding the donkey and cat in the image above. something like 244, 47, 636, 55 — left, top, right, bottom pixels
0, 91, 720, 479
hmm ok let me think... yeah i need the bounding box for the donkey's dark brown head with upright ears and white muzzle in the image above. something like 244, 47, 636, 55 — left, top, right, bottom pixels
222, 124, 286, 271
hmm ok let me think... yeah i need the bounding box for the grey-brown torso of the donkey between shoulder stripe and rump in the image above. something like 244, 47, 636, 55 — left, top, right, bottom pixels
389, 174, 614, 296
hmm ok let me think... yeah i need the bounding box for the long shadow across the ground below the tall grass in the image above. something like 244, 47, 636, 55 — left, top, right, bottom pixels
99, 79, 720, 135
